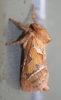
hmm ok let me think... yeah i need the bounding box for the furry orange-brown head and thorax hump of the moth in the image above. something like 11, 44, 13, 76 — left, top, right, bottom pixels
31, 23, 51, 44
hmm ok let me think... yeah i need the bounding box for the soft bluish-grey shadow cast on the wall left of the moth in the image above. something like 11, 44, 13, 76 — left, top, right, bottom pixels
3, 3, 31, 89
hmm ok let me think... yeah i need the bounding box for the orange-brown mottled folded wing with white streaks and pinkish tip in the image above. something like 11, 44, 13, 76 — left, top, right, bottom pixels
21, 36, 49, 92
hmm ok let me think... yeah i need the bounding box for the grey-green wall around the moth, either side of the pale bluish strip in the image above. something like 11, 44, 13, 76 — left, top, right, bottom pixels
0, 0, 61, 100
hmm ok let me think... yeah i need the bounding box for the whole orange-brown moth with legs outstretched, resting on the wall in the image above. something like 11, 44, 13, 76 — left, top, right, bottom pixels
6, 5, 51, 92
